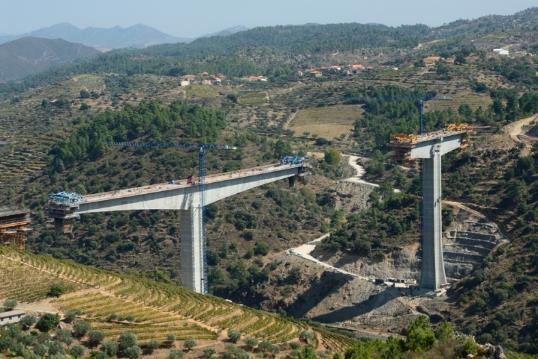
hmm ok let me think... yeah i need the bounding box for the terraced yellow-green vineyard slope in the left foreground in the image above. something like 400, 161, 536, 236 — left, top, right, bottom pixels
0, 247, 354, 352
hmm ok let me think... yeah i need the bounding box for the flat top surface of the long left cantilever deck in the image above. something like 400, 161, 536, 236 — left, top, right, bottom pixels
80, 163, 307, 204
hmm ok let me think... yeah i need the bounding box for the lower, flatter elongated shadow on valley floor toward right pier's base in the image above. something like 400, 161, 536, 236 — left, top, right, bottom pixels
312, 288, 402, 323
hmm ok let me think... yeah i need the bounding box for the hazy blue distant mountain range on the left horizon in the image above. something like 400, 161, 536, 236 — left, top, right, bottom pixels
0, 23, 247, 50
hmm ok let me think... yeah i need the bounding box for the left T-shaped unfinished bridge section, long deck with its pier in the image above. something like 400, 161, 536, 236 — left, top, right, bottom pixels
48, 161, 307, 293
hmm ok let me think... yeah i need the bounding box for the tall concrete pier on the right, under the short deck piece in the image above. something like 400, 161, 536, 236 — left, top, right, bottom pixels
420, 144, 447, 290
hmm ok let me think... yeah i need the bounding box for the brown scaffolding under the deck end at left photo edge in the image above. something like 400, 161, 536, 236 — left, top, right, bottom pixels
0, 208, 30, 249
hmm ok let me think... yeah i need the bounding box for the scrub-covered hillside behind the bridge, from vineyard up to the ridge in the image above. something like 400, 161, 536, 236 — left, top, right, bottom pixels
0, 9, 538, 358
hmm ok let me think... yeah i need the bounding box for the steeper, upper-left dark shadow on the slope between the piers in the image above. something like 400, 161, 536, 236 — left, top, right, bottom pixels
287, 271, 353, 318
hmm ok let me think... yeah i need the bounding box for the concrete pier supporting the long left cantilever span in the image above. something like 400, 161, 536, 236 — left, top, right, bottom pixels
179, 206, 205, 294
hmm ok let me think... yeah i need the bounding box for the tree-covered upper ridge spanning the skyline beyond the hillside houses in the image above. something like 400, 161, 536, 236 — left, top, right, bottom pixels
0, 8, 538, 94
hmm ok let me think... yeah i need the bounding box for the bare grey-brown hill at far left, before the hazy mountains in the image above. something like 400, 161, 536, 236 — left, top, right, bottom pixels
0, 37, 98, 82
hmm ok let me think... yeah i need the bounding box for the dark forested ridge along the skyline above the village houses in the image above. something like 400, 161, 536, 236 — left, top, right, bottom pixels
0, 8, 538, 94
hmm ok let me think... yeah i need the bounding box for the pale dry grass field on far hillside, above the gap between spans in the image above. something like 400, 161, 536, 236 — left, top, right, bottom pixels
288, 105, 363, 139
